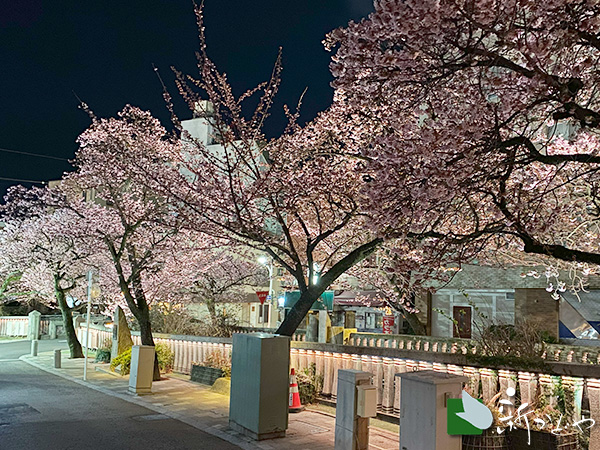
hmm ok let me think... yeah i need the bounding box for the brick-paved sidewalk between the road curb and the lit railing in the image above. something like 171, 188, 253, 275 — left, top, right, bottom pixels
20, 352, 398, 450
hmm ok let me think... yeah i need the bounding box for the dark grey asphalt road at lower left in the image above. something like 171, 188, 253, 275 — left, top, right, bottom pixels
0, 341, 239, 450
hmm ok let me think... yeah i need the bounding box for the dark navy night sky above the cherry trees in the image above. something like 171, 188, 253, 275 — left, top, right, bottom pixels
0, 0, 372, 196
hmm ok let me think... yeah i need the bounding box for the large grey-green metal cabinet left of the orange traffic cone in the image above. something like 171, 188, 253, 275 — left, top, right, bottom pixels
229, 333, 290, 440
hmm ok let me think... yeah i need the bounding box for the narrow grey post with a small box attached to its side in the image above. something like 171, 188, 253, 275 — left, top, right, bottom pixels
335, 369, 375, 450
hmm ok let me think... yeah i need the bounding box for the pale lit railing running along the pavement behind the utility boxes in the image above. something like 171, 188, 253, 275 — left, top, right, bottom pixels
77, 327, 600, 432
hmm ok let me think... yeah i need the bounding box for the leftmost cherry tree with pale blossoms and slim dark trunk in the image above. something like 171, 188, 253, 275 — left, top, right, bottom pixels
0, 188, 98, 358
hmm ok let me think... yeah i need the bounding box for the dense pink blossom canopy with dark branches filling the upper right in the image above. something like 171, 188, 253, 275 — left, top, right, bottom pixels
325, 0, 600, 288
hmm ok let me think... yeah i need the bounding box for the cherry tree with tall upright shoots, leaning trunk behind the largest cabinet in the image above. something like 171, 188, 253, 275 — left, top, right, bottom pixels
133, 3, 390, 335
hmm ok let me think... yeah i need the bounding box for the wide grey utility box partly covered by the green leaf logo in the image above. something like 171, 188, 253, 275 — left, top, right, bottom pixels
396, 370, 469, 450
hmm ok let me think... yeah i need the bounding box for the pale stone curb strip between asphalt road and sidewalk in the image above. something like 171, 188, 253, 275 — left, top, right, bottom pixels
19, 355, 264, 450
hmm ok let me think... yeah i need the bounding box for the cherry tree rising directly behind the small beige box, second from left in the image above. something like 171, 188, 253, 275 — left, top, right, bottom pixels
60, 106, 186, 379
